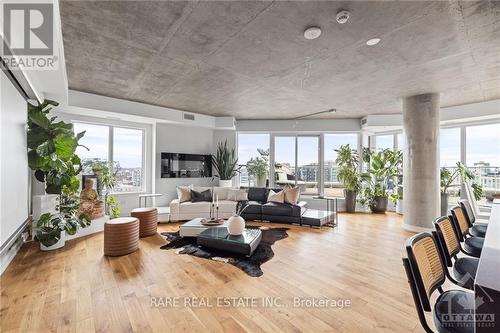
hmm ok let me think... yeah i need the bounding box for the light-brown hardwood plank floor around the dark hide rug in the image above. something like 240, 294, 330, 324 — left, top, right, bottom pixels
0, 214, 431, 333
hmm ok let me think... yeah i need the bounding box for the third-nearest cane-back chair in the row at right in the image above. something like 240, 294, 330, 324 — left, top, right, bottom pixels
451, 206, 484, 258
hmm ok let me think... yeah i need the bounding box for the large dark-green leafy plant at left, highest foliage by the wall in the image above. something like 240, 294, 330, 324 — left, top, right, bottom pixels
27, 100, 85, 194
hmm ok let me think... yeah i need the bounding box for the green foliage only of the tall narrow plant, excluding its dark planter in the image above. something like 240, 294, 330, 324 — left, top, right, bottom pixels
335, 145, 361, 192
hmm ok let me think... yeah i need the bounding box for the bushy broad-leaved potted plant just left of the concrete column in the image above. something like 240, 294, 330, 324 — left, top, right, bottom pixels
359, 148, 403, 213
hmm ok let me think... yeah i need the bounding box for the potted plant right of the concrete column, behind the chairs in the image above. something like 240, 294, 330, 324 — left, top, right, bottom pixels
440, 162, 483, 216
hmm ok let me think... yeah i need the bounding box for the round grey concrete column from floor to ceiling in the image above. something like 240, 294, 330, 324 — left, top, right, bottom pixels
403, 94, 440, 232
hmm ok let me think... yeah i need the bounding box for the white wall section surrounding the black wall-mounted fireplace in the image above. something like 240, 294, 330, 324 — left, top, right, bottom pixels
155, 124, 218, 206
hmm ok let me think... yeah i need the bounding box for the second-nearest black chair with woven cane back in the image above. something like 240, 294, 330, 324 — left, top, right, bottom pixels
433, 216, 479, 290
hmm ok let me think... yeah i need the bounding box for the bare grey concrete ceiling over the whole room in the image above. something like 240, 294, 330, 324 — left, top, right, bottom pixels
60, 0, 500, 119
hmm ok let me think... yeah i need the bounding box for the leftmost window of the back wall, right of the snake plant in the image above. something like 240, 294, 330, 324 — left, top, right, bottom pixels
238, 133, 269, 187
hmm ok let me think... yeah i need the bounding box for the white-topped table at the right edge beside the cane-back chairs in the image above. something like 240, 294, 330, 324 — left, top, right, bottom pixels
474, 199, 500, 333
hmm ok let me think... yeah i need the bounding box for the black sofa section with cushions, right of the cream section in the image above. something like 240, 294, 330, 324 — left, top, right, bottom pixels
241, 187, 305, 224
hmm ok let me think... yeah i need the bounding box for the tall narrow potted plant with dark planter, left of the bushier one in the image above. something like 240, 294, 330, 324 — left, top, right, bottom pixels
335, 145, 361, 213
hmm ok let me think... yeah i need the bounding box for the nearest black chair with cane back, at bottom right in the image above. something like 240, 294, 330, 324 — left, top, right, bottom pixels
403, 232, 475, 333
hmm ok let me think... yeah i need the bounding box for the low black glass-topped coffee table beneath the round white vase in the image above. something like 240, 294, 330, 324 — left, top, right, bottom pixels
196, 228, 262, 257
